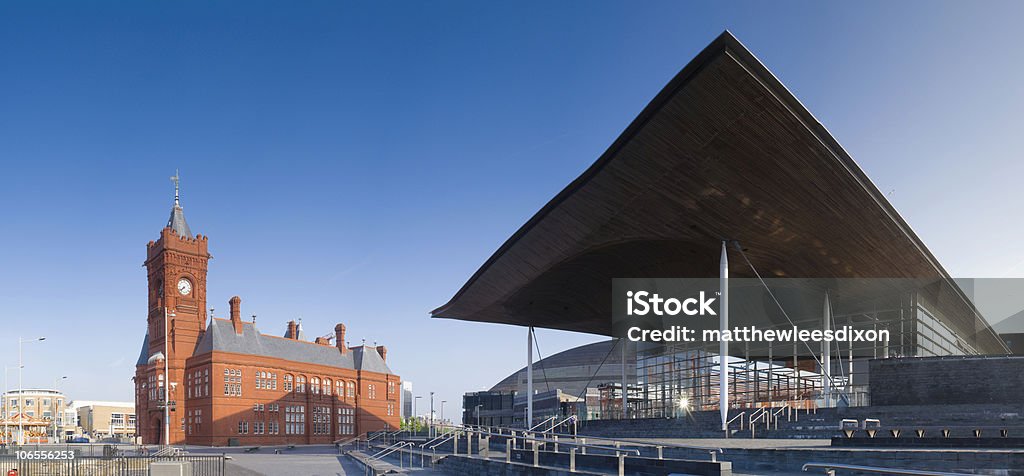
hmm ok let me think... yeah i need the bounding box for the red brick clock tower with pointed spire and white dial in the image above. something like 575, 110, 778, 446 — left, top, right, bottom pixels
136, 174, 211, 444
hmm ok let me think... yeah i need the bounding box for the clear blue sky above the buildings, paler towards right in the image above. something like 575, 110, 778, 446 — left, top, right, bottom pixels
0, 1, 1024, 412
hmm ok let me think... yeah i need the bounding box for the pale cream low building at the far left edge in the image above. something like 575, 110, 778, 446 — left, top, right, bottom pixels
0, 388, 75, 442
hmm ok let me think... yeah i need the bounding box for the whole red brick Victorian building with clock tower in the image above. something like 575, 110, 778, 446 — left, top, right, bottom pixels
134, 179, 400, 445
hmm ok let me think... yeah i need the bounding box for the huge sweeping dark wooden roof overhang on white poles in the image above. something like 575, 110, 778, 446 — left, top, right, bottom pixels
432, 32, 1006, 353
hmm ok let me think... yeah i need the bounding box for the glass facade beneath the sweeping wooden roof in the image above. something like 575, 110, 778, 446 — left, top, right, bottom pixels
597, 286, 979, 419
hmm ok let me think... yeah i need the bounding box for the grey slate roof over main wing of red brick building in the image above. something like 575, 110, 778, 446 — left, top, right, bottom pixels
189, 318, 391, 374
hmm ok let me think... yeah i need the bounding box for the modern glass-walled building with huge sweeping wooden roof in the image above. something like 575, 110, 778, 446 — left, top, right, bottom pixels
432, 33, 1009, 421
